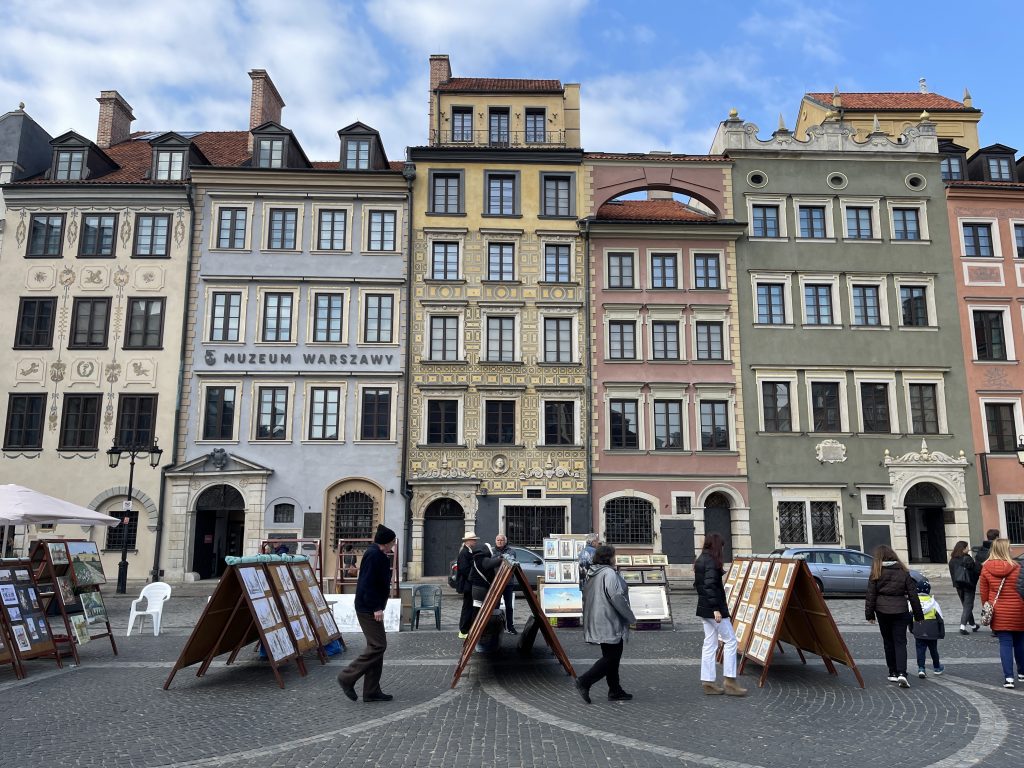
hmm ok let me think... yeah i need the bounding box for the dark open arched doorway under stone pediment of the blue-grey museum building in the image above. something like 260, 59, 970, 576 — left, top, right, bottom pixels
193, 485, 246, 579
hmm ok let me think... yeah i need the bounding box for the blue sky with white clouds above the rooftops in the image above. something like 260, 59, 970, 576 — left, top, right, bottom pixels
0, 0, 1024, 160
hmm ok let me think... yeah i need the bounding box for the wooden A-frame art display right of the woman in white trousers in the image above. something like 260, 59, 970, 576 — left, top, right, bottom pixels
733, 557, 864, 688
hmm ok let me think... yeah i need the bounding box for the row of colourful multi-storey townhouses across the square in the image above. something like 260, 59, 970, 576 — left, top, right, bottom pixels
0, 55, 1024, 581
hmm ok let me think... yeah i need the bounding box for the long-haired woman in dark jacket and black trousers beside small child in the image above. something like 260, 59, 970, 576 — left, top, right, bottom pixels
864, 544, 925, 688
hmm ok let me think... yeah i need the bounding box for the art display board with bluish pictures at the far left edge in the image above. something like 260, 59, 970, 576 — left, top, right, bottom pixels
0, 559, 63, 679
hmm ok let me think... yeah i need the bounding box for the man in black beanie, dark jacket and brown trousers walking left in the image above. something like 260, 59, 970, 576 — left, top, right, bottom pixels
338, 525, 396, 701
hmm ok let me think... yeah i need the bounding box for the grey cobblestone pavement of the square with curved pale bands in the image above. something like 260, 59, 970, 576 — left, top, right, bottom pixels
0, 588, 1024, 768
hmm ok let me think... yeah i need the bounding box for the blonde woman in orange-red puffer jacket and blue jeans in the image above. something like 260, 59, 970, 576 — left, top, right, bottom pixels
978, 539, 1024, 688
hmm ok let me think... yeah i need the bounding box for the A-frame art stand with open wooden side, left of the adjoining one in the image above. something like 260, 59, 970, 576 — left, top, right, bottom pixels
164, 562, 306, 690
